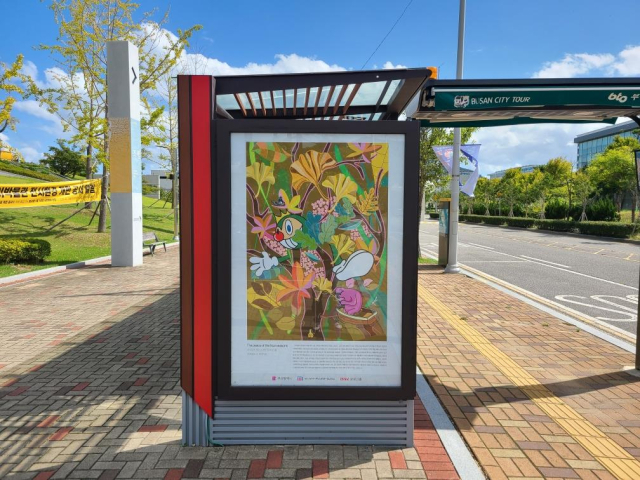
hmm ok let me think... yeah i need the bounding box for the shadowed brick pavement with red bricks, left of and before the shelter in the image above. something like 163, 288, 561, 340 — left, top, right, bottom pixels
0, 249, 458, 480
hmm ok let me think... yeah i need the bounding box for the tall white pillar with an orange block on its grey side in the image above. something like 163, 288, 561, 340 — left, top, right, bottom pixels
107, 41, 142, 267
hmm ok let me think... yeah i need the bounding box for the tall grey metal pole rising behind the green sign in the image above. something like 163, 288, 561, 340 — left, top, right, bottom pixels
444, 0, 466, 273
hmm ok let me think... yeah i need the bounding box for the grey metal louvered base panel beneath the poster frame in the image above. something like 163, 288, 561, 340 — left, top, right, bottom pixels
208, 400, 413, 446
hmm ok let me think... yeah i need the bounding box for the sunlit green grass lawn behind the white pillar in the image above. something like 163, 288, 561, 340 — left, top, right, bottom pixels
0, 196, 173, 277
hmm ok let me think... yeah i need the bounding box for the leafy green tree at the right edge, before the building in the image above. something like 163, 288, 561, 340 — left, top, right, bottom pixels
587, 146, 638, 222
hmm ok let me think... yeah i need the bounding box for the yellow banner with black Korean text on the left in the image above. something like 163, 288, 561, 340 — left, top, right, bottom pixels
0, 179, 102, 208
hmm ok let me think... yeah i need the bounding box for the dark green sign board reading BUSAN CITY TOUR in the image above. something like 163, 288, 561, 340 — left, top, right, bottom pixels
430, 86, 640, 111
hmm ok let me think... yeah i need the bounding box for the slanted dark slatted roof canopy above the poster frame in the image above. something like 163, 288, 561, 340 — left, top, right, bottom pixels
215, 67, 437, 120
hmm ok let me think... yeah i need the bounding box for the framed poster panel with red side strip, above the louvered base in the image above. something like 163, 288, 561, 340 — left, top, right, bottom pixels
178, 76, 419, 442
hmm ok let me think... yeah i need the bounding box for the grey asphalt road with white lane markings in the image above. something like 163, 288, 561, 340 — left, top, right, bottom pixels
420, 220, 640, 334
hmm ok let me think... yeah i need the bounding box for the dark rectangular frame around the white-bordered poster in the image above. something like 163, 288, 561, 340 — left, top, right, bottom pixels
214, 120, 420, 400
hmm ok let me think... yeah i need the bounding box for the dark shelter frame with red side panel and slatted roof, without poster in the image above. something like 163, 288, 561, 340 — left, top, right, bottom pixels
178, 68, 436, 417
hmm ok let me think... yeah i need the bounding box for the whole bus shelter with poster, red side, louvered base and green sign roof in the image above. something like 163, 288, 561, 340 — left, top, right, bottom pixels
178, 68, 640, 446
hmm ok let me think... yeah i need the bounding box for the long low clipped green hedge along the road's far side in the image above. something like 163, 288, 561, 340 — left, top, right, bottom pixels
459, 215, 640, 238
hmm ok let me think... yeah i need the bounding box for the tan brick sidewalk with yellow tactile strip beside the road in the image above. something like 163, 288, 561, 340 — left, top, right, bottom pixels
418, 268, 640, 480
